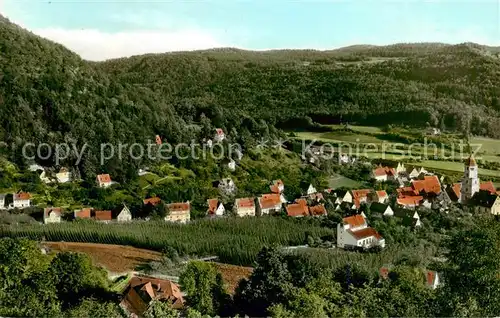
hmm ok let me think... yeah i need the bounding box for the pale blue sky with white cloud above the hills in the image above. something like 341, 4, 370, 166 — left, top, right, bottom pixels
0, 0, 500, 61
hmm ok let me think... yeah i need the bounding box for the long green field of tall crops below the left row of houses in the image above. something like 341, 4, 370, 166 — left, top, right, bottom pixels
0, 217, 333, 265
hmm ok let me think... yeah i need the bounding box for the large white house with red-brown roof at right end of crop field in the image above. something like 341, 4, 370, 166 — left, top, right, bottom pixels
337, 214, 385, 248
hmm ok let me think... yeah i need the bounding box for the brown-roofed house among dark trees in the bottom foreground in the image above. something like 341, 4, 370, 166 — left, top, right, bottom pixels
120, 276, 184, 317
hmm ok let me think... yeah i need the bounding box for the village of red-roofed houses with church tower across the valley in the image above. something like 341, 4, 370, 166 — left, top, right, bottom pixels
0, 129, 500, 256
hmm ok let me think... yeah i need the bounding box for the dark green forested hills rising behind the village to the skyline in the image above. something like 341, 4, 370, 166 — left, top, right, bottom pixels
0, 14, 500, 176
